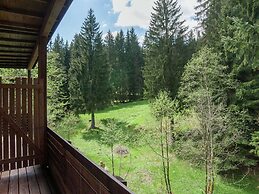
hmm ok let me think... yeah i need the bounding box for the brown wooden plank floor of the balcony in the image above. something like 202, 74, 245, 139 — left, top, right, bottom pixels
0, 165, 57, 194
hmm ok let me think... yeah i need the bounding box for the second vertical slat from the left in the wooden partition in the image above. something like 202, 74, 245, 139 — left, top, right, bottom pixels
9, 88, 16, 169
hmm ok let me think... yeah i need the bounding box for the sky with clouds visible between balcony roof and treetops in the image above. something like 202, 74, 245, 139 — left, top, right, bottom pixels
52, 0, 196, 42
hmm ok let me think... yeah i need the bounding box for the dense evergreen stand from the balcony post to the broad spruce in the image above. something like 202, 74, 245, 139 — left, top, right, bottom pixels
48, 10, 144, 128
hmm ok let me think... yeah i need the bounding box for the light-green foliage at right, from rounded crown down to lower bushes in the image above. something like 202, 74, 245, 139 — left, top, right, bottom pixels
179, 47, 255, 171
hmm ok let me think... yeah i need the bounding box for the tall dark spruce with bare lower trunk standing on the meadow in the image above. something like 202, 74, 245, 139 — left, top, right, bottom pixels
77, 9, 110, 128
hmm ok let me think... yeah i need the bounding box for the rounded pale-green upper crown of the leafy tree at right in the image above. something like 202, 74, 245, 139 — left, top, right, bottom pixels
180, 46, 232, 104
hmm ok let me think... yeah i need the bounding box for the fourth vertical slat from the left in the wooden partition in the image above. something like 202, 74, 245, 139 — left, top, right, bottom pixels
22, 78, 28, 167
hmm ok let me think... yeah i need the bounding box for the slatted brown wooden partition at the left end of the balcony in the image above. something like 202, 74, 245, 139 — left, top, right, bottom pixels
0, 77, 44, 171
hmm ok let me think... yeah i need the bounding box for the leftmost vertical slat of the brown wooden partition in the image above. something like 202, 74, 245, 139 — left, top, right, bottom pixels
3, 88, 9, 170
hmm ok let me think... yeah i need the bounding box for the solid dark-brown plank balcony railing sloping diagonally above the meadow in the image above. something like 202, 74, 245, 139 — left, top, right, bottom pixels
47, 129, 132, 194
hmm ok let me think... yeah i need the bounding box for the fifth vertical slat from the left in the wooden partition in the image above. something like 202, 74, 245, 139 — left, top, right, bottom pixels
28, 78, 34, 166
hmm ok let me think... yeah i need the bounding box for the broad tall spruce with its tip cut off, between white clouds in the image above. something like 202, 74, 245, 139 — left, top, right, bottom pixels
143, 0, 186, 98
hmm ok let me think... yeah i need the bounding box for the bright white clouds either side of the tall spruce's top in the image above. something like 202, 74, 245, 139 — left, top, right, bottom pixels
112, 0, 199, 29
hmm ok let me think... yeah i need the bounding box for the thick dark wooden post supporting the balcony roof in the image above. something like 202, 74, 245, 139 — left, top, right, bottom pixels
38, 37, 47, 164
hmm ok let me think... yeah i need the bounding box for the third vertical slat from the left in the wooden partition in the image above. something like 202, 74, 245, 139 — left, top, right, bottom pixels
15, 78, 22, 168
